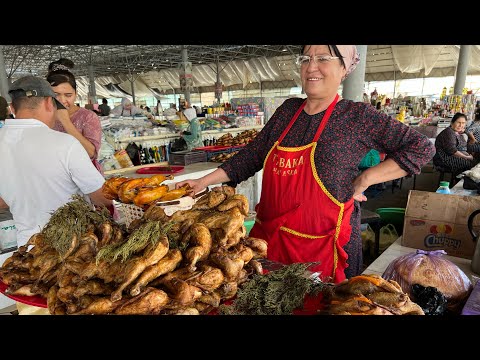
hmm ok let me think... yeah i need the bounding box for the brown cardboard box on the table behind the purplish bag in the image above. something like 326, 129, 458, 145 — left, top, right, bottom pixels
402, 190, 480, 259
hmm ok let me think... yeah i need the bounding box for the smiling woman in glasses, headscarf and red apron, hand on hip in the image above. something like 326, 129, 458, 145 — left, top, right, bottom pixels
177, 45, 435, 283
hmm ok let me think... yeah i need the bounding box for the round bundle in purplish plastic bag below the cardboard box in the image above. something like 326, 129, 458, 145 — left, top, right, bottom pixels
382, 250, 472, 313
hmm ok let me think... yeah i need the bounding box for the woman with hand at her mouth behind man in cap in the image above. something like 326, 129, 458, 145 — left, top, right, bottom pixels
47, 58, 103, 174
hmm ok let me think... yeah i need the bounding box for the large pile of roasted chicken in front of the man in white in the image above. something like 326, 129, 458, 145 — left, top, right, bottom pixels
0, 186, 267, 314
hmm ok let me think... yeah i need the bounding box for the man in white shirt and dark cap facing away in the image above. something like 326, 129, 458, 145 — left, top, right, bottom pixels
0, 76, 112, 246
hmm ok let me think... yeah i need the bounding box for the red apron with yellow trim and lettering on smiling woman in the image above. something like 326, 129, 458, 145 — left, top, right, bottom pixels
250, 95, 353, 283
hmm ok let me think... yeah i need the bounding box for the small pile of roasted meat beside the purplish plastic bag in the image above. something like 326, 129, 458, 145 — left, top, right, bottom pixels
322, 275, 424, 315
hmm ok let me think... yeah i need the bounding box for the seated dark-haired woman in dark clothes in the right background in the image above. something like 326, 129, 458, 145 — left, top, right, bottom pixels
433, 113, 480, 176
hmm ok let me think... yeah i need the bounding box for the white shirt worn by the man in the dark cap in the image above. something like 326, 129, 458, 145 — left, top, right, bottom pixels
0, 119, 105, 246
